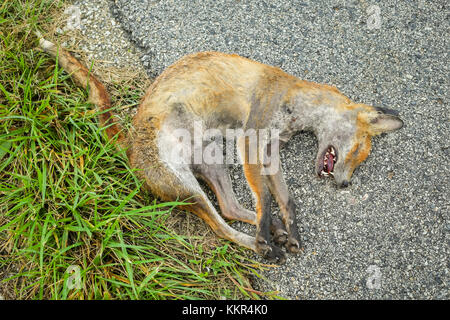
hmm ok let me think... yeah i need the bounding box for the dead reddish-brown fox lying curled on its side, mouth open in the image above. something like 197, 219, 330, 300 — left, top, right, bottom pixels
38, 35, 403, 263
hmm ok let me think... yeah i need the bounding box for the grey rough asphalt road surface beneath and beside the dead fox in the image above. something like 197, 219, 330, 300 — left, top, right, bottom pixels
75, 0, 450, 299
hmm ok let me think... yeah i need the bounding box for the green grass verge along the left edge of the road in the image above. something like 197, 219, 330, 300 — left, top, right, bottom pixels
0, 0, 273, 299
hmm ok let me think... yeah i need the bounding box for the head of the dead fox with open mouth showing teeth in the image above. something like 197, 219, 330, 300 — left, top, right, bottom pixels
316, 104, 403, 187
